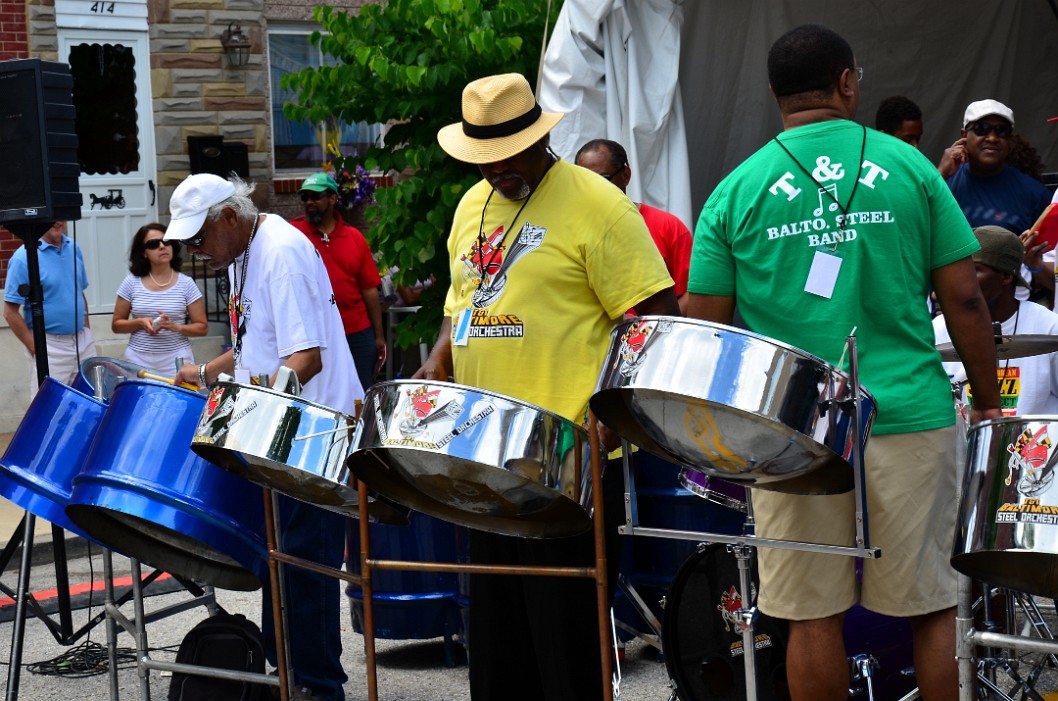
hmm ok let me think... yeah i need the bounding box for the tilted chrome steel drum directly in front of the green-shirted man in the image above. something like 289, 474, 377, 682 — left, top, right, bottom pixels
591, 316, 875, 494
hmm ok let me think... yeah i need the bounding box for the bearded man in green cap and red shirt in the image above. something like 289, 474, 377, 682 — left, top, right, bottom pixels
290, 172, 386, 389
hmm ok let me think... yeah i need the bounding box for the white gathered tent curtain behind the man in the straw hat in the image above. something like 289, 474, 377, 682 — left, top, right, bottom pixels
540, 0, 692, 225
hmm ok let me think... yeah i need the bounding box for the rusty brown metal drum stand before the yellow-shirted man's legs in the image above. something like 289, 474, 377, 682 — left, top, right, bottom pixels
265, 413, 614, 701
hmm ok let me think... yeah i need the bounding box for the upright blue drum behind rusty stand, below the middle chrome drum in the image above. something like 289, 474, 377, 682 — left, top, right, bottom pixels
346, 511, 467, 641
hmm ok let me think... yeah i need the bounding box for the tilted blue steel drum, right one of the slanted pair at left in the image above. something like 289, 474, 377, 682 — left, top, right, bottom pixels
67, 380, 268, 591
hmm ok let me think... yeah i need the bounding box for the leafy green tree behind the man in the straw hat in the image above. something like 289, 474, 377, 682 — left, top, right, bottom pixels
282, 0, 561, 346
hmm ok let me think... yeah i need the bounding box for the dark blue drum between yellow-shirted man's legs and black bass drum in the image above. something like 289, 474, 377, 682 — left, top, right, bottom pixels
614, 450, 746, 642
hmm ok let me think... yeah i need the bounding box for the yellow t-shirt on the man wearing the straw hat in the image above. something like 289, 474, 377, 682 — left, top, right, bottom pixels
444, 161, 673, 423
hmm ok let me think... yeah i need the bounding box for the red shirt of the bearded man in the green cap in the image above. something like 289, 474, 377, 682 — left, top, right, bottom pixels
290, 211, 382, 334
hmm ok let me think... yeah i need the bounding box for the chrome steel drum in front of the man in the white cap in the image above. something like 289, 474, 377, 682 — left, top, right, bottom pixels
191, 382, 407, 525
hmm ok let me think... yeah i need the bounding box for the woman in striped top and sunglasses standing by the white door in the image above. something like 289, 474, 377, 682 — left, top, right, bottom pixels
110, 224, 208, 376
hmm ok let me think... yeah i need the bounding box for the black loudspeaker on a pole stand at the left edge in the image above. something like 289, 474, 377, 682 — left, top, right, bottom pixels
0, 58, 81, 224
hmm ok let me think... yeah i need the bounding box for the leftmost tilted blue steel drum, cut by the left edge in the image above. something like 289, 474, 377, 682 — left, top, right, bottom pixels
0, 377, 107, 537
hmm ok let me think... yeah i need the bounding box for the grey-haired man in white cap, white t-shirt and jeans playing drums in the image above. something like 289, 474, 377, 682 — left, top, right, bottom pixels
165, 173, 364, 701
